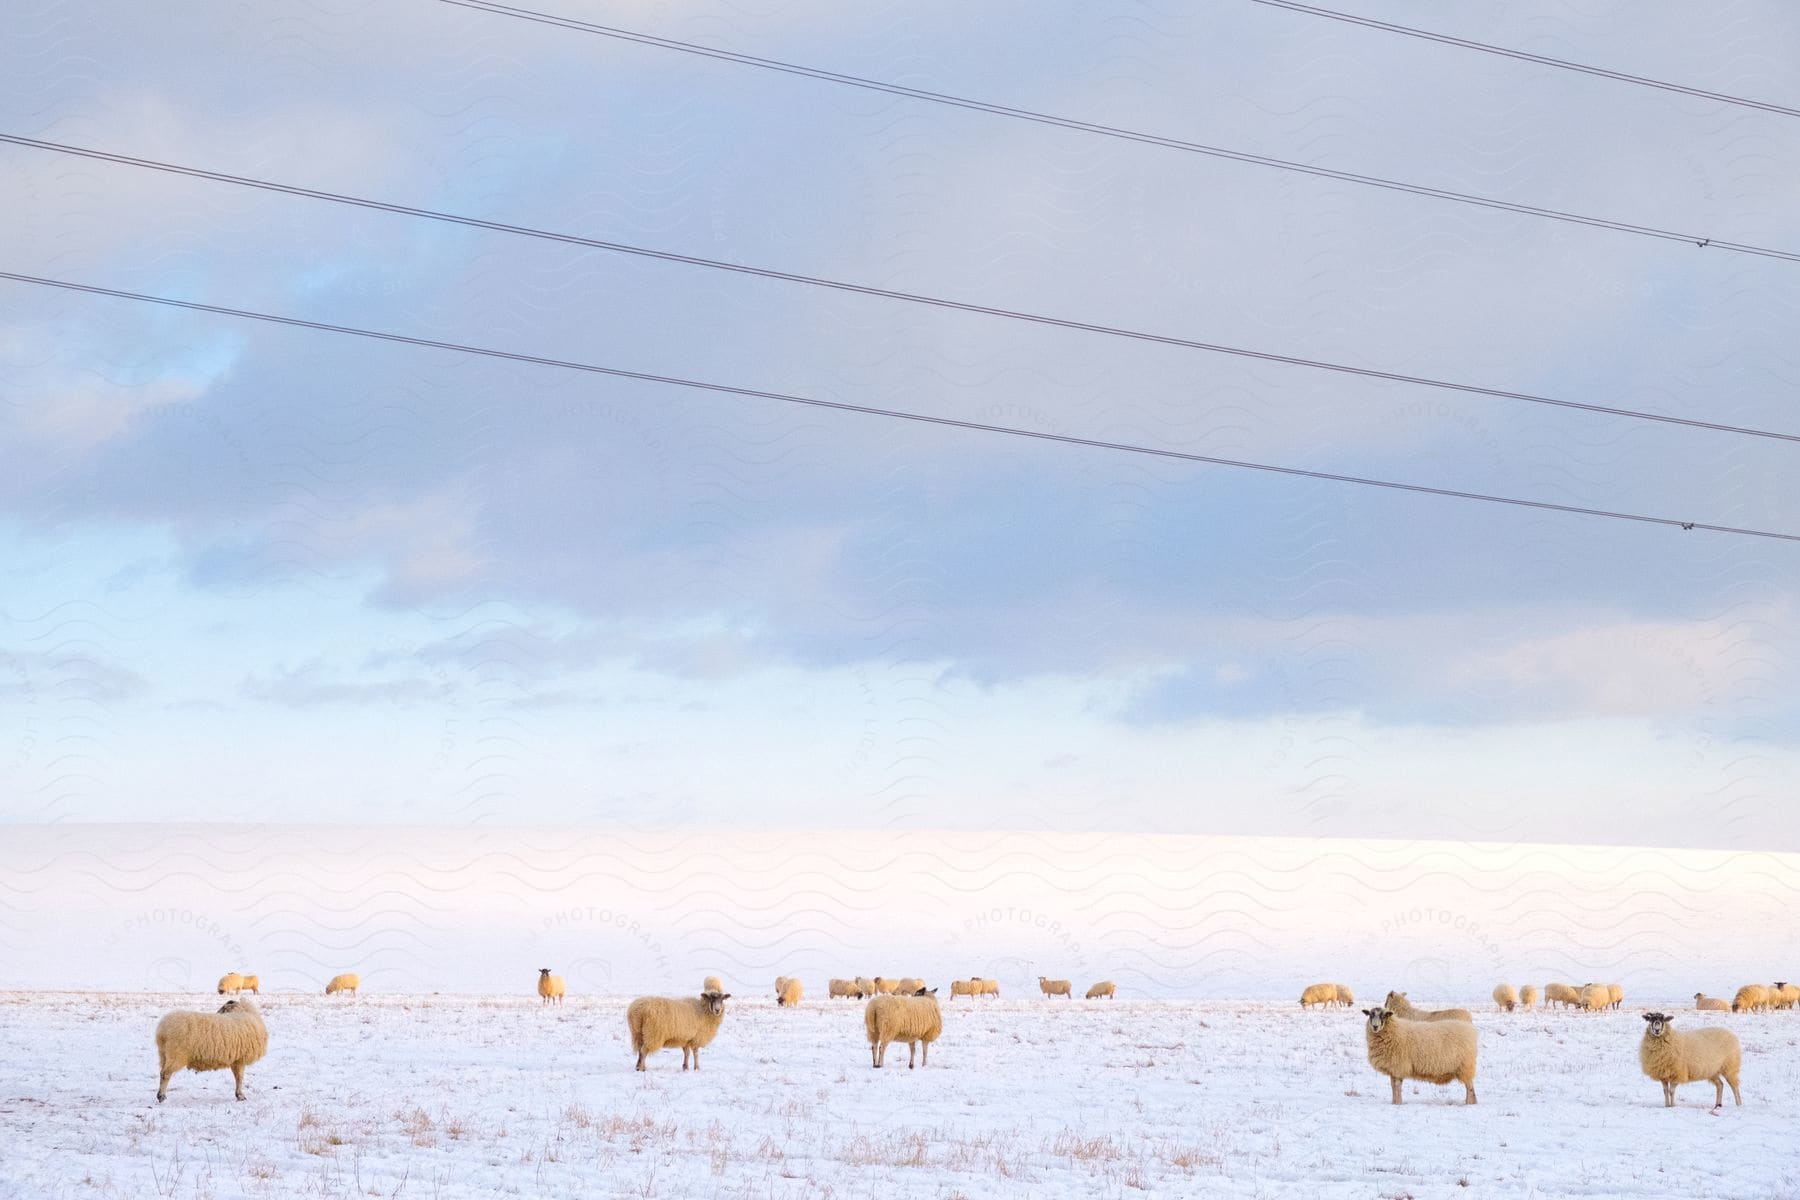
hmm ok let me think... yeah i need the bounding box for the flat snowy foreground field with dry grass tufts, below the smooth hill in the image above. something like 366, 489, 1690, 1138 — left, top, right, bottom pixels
0, 991, 1800, 1200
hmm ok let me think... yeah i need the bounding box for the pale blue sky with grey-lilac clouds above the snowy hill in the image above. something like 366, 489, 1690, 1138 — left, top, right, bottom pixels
0, 0, 1800, 851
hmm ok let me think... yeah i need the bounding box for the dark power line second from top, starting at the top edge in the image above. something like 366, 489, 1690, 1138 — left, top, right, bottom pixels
437, 0, 1800, 263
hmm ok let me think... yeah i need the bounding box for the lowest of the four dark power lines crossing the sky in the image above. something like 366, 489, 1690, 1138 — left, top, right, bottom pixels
0, 272, 1800, 542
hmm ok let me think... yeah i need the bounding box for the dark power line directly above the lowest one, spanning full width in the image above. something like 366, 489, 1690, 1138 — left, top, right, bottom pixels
0, 133, 1800, 443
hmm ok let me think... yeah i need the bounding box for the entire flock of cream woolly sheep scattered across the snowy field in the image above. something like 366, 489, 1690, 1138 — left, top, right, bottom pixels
157, 966, 1800, 1108
